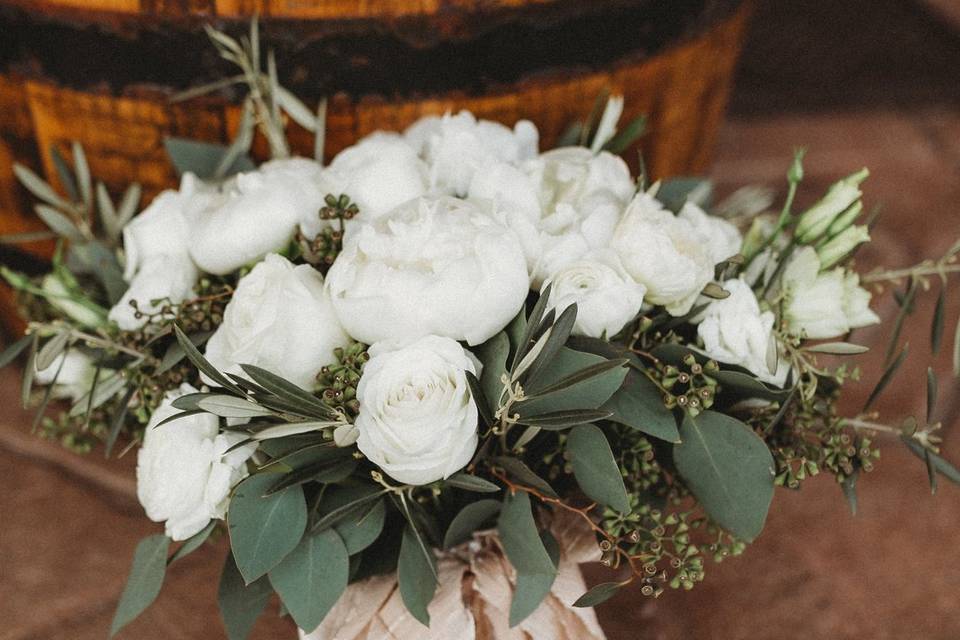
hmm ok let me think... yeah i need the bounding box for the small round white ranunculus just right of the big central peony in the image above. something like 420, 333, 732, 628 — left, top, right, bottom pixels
543, 249, 646, 338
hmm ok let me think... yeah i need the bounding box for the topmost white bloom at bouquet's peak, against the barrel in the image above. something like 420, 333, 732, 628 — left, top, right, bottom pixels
403, 111, 540, 196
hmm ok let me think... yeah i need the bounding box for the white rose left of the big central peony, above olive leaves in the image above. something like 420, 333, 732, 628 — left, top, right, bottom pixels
206, 254, 349, 388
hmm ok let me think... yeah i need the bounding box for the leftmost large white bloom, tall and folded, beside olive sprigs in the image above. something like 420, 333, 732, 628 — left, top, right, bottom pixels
108, 173, 208, 331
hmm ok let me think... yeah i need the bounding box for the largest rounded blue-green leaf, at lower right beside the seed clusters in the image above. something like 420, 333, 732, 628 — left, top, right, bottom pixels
673, 411, 774, 541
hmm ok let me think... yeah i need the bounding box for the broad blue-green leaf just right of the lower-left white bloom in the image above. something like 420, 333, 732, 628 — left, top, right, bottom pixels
227, 474, 307, 584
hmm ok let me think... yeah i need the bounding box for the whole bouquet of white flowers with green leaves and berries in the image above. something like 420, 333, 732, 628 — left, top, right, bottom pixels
0, 22, 960, 638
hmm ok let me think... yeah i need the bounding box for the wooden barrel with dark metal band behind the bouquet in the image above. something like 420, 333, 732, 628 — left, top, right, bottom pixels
0, 0, 751, 330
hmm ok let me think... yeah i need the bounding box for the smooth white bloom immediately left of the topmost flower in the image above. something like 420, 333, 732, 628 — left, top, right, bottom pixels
300, 131, 427, 237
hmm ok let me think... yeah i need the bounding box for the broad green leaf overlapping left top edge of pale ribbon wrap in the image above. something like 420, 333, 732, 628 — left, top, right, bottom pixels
270, 529, 350, 633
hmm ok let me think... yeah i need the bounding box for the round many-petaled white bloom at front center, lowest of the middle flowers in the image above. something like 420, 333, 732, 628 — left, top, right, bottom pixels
356, 336, 480, 485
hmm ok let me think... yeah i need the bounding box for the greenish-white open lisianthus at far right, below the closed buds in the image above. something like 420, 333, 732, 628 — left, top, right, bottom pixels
783, 247, 880, 340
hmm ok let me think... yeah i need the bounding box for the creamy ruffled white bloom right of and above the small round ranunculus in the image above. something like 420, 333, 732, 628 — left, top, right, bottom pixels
612, 193, 715, 316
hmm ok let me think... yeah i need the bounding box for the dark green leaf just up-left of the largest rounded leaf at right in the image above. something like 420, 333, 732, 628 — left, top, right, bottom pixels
601, 370, 680, 442
